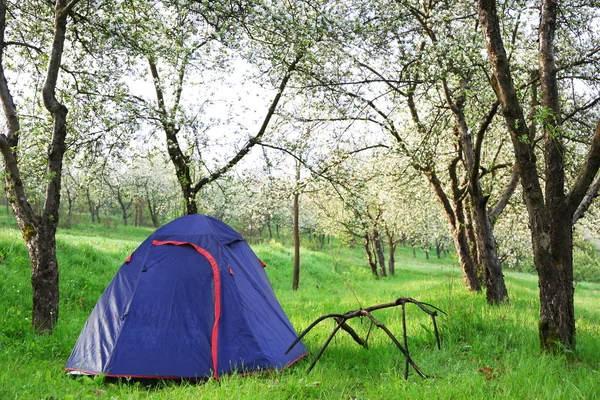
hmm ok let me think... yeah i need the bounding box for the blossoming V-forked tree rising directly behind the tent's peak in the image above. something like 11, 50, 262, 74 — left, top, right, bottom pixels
104, 1, 314, 214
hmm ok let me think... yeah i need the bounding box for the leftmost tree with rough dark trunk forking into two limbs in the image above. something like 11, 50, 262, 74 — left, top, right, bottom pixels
0, 0, 79, 333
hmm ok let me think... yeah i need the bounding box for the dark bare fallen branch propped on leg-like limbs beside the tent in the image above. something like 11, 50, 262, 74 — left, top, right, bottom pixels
285, 297, 447, 379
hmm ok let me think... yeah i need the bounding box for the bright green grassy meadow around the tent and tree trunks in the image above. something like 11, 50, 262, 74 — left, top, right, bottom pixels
0, 219, 600, 399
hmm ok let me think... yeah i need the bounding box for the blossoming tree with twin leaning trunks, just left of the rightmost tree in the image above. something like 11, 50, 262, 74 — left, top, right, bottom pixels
290, 1, 520, 296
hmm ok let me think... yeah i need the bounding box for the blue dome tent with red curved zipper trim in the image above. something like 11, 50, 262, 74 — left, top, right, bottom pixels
66, 214, 307, 379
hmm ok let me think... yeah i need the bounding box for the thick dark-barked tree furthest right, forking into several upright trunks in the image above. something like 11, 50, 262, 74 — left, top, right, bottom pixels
477, 0, 600, 350
